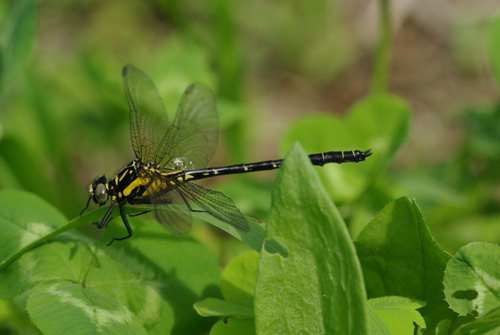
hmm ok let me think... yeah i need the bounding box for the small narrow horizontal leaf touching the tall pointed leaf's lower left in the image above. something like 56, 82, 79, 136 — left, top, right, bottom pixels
194, 298, 253, 319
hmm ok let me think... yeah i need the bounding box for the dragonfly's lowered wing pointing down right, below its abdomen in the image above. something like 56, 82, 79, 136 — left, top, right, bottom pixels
178, 183, 250, 231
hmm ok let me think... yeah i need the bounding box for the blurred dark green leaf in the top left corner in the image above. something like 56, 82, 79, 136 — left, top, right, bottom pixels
0, 0, 37, 81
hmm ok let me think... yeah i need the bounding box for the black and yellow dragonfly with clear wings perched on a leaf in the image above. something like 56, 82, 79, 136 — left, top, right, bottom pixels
80, 65, 372, 245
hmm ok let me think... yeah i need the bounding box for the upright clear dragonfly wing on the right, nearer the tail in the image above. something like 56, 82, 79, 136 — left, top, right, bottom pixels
156, 83, 219, 170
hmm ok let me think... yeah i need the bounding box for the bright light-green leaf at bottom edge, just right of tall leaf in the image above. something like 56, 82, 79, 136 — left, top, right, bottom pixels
368, 296, 425, 335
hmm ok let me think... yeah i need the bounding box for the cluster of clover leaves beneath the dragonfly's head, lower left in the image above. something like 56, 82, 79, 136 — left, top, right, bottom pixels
0, 191, 220, 334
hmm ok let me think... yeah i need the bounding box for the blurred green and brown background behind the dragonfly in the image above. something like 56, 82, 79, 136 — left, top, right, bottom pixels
0, 0, 500, 255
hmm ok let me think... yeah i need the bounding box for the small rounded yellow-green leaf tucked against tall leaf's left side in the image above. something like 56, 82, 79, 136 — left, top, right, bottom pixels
220, 250, 259, 308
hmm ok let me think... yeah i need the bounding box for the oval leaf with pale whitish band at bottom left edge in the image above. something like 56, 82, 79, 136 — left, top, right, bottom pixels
27, 283, 147, 335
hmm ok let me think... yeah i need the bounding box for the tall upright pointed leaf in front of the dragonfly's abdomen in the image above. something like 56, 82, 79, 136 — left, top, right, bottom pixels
255, 145, 368, 335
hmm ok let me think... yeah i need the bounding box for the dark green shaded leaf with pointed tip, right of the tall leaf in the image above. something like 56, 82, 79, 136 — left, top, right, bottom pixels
355, 197, 455, 329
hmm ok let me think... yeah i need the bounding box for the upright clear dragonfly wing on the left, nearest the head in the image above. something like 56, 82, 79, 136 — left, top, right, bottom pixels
123, 65, 168, 162
